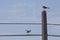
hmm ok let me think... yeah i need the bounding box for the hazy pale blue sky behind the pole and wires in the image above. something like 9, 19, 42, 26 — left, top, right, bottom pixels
0, 0, 60, 40
